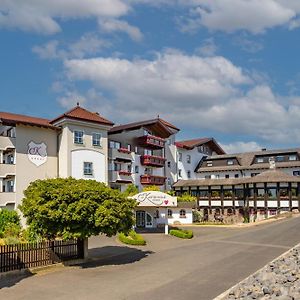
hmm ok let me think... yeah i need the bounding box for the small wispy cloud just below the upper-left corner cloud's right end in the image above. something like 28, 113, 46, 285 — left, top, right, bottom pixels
98, 19, 143, 42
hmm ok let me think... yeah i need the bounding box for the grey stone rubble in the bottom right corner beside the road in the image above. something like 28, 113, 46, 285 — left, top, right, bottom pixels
223, 246, 300, 300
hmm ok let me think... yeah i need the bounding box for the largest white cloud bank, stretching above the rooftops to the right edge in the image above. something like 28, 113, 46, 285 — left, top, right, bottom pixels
65, 50, 300, 144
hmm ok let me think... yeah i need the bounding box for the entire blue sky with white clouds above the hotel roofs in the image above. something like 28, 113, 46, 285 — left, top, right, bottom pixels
0, 0, 300, 152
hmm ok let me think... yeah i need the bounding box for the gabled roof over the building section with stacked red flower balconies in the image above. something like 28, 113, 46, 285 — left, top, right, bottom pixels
108, 118, 173, 138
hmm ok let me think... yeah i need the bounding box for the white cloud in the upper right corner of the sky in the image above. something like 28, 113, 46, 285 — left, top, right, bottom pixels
177, 0, 300, 34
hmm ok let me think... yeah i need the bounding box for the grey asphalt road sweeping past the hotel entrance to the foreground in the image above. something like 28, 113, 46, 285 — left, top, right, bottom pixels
0, 218, 300, 300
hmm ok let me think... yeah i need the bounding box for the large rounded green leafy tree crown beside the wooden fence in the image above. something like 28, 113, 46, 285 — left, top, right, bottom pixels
19, 177, 136, 239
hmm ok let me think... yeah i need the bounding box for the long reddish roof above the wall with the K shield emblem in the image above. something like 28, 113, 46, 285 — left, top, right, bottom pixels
0, 112, 58, 129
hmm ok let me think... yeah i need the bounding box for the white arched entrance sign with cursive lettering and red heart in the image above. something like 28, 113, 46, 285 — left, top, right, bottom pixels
132, 191, 177, 207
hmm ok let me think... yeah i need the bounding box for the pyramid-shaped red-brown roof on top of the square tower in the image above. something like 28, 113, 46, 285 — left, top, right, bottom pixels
50, 104, 114, 126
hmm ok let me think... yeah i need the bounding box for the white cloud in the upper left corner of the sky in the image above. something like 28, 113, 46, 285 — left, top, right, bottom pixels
0, 0, 130, 34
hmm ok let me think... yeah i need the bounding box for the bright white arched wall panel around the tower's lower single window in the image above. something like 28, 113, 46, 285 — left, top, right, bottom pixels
71, 149, 106, 182
